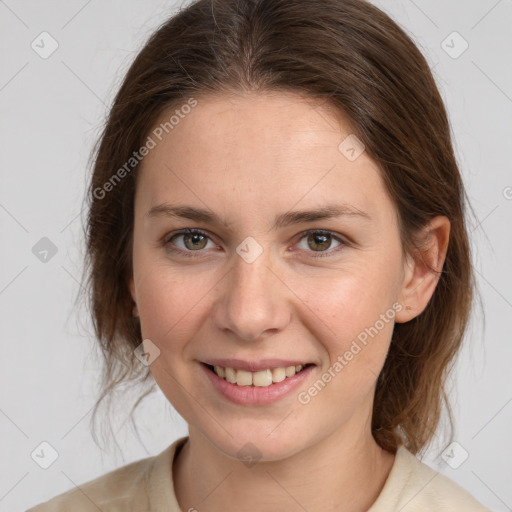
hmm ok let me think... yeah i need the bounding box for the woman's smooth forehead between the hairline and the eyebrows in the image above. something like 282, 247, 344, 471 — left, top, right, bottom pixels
137, 93, 389, 226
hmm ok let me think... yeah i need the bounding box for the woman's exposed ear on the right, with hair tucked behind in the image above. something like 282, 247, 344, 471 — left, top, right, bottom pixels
395, 215, 450, 323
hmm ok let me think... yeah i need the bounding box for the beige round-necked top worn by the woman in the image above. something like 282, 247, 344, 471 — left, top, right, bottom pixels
27, 437, 490, 512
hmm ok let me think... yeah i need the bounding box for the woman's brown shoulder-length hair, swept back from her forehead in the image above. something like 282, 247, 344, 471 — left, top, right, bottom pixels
79, 0, 474, 453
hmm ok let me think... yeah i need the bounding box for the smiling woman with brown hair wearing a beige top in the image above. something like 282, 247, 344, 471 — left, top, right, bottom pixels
31, 0, 487, 512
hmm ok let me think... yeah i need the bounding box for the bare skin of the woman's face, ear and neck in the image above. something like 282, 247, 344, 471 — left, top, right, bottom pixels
130, 92, 450, 512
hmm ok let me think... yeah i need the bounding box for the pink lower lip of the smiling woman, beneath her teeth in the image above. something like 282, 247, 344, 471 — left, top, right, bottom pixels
200, 363, 315, 405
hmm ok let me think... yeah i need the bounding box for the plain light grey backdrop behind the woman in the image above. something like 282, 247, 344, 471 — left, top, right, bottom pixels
0, 0, 512, 511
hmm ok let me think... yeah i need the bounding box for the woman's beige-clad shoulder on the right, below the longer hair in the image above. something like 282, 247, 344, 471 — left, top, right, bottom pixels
369, 446, 490, 512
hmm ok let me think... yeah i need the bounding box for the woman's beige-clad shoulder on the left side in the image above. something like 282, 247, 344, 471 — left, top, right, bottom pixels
26, 444, 174, 512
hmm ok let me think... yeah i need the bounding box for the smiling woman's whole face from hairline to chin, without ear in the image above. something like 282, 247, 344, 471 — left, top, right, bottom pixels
130, 93, 406, 460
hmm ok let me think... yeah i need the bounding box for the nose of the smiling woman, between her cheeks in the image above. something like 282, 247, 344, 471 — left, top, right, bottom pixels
213, 246, 292, 341
